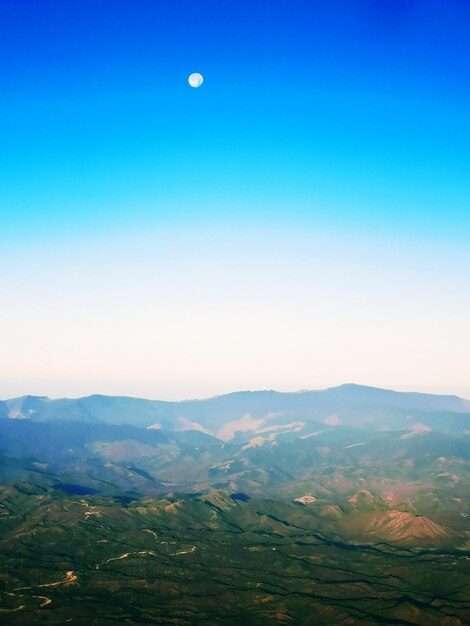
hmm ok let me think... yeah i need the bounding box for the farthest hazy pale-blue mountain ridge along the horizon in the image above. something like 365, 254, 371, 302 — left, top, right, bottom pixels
0, 384, 470, 441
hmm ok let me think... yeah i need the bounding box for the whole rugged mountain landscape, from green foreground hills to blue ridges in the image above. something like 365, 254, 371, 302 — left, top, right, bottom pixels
0, 385, 470, 626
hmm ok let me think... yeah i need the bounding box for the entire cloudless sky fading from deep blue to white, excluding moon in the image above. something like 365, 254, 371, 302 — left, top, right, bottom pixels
0, 0, 470, 397
